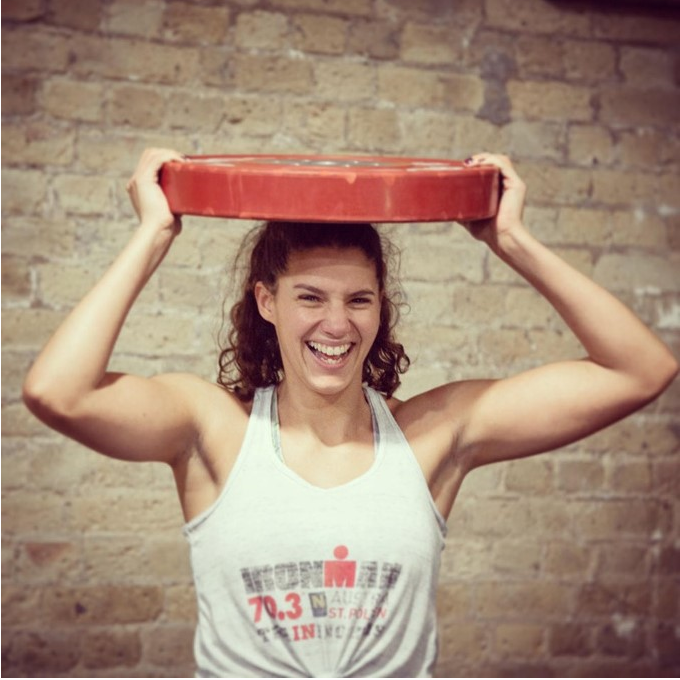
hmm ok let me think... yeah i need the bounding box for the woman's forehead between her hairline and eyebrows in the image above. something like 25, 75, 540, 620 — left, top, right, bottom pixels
281, 247, 378, 286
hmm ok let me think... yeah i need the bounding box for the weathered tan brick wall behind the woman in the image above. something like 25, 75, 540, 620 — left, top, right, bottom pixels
2, 0, 680, 676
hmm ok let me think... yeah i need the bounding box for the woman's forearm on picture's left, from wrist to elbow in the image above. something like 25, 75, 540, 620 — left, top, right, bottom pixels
24, 227, 174, 408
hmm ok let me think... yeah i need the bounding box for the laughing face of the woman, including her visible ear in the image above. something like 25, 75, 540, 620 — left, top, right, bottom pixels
255, 247, 381, 394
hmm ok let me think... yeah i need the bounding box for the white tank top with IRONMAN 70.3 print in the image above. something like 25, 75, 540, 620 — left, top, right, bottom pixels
184, 387, 446, 678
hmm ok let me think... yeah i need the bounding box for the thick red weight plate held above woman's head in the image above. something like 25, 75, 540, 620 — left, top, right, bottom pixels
160, 155, 500, 222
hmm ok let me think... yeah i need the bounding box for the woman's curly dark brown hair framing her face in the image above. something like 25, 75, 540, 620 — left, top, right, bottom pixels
217, 222, 410, 401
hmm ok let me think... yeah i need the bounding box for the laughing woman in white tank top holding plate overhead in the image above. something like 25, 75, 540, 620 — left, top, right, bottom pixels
24, 150, 678, 677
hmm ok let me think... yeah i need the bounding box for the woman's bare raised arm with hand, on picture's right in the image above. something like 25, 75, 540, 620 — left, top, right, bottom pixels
448, 154, 678, 466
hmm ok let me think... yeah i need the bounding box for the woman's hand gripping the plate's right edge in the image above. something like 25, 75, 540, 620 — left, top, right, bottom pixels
461, 153, 526, 251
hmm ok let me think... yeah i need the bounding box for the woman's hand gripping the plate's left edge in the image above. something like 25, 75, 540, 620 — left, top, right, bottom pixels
126, 149, 185, 236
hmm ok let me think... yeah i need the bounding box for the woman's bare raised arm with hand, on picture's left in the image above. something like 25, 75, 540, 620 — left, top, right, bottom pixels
24, 150, 206, 463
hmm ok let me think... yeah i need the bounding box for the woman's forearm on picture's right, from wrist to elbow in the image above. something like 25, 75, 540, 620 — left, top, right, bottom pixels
494, 229, 677, 391
